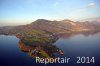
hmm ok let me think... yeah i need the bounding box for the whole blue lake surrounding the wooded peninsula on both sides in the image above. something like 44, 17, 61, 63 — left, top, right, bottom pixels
0, 32, 100, 66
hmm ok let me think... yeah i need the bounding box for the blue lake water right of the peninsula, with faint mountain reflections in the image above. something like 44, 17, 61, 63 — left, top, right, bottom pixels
55, 32, 100, 66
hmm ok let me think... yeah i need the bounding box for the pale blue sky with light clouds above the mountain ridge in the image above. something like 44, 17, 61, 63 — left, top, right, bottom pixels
0, 0, 100, 26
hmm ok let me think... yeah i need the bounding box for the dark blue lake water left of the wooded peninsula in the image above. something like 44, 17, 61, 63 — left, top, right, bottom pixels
0, 35, 38, 66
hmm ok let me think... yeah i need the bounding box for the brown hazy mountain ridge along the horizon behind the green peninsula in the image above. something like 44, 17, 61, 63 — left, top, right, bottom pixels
0, 19, 100, 34
